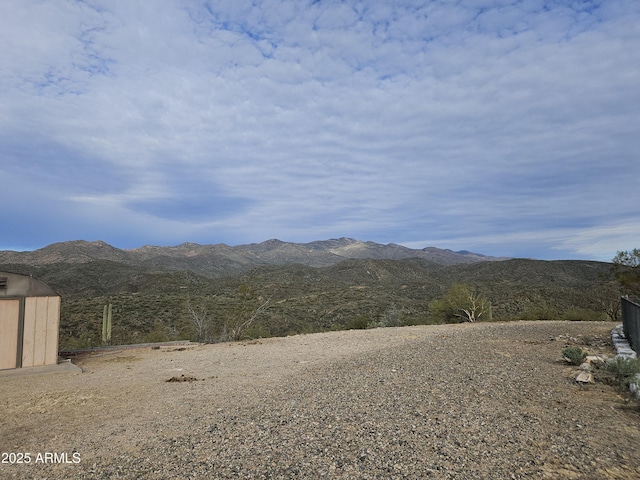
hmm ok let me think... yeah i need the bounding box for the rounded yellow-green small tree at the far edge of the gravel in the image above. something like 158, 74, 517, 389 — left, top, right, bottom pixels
429, 283, 491, 322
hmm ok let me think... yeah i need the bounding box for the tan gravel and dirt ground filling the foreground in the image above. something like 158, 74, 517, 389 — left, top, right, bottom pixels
0, 322, 640, 479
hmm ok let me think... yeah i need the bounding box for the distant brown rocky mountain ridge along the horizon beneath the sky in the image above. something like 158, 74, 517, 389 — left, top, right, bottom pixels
0, 237, 506, 277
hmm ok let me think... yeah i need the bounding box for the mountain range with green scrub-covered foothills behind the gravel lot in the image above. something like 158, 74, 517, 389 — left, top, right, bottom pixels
0, 238, 620, 349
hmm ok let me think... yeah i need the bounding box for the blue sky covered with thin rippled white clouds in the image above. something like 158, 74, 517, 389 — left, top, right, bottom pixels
0, 0, 640, 261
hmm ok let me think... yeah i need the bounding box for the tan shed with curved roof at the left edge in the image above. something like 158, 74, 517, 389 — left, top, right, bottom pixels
0, 272, 60, 370
